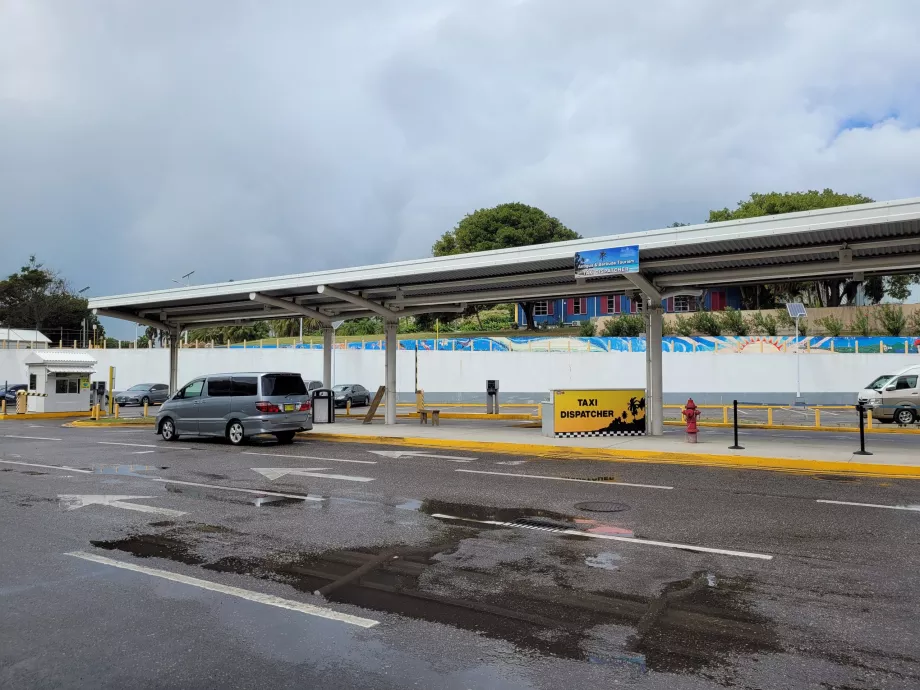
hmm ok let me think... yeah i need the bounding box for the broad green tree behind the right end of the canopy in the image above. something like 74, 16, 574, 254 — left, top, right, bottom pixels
709, 189, 920, 309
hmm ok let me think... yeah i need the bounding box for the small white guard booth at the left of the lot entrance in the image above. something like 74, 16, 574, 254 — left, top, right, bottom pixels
24, 350, 96, 412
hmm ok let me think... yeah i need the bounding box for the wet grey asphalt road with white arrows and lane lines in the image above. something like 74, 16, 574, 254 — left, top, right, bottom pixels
0, 422, 920, 688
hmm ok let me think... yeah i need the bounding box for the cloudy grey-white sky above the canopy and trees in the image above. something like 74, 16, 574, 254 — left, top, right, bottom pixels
0, 0, 920, 334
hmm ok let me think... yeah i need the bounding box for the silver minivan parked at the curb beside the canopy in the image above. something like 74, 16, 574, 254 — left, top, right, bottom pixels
156, 372, 313, 446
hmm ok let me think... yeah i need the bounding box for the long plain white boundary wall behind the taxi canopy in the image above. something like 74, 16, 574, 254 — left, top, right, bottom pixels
0, 349, 908, 403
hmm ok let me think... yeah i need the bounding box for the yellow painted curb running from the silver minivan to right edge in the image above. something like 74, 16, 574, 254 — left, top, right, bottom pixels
300, 432, 920, 479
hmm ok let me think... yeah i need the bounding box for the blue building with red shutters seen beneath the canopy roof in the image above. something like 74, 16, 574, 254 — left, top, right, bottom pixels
515, 287, 741, 325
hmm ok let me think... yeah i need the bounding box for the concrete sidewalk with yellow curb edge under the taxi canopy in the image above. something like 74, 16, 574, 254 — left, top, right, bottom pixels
306, 420, 920, 478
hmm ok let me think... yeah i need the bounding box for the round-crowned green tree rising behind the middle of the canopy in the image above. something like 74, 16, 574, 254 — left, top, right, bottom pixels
431, 202, 581, 330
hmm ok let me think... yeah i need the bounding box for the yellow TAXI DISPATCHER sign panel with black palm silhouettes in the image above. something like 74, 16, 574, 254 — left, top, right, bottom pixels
553, 389, 645, 436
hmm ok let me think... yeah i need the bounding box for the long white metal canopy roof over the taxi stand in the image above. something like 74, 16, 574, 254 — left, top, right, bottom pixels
89, 198, 920, 328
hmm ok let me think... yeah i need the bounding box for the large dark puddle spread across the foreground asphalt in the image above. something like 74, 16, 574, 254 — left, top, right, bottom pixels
91, 500, 782, 679
